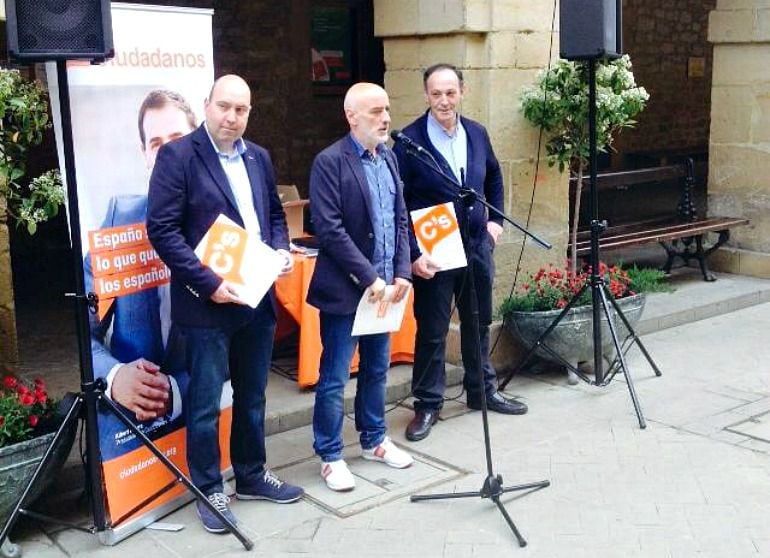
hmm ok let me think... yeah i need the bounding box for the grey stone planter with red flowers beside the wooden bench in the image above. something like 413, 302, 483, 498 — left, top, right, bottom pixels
506, 293, 646, 365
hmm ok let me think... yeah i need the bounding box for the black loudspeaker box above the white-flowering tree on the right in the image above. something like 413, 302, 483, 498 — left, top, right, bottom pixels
559, 0, 623, 60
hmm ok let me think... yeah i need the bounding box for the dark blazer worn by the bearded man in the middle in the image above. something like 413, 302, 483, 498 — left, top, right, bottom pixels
307, 136, 412, 314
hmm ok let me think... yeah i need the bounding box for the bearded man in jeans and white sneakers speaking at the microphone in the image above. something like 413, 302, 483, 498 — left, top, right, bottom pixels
307, 83, 412, 491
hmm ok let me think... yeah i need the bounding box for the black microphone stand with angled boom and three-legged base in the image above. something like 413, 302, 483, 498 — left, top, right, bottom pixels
405, 145, 551, 547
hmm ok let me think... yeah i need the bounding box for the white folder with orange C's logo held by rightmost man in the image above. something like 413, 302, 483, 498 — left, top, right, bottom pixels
409, 202, 468, 271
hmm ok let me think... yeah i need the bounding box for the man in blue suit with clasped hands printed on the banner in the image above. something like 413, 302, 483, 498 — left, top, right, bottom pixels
84, 89, 196, 461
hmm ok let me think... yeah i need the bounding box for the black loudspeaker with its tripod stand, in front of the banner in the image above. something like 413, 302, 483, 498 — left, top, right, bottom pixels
0, 0, 254, 555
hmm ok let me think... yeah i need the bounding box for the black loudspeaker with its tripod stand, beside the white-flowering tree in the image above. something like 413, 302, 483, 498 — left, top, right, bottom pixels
499, 0, 661, 434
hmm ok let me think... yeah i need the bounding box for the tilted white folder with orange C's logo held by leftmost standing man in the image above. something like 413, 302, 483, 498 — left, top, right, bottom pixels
195, 214, 286, 308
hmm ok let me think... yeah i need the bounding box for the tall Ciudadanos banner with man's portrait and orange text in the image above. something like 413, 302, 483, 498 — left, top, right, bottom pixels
48, 3, 220, 544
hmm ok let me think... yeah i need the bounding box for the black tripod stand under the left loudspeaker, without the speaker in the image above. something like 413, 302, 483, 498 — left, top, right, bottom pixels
0, 60, 254, 550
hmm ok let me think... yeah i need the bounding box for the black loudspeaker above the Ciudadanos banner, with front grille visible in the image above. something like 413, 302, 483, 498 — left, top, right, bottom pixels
5, 0, 114, 62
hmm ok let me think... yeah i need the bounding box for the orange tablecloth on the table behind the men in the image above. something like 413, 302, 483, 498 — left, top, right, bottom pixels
275, 255, 416, 387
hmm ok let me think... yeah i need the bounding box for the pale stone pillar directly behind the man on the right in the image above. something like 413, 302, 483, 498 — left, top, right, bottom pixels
374, 0, 569, 368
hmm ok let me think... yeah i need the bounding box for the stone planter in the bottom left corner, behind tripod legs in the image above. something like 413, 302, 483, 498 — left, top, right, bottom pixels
0, 422, 77, 558
